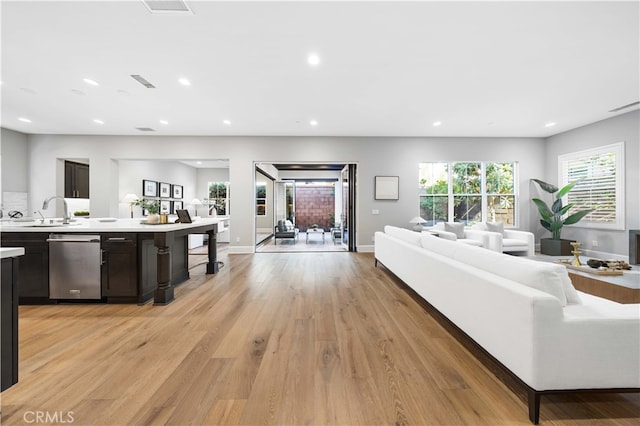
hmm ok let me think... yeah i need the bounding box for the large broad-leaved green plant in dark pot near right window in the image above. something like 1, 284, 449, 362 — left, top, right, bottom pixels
531, 179, 594, 256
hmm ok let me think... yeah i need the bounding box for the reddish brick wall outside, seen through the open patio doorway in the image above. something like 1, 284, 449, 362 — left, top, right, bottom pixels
296, 184, 336, 232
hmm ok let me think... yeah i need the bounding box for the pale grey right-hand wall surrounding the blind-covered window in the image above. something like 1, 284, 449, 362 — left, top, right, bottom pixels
535, 110, 640, 256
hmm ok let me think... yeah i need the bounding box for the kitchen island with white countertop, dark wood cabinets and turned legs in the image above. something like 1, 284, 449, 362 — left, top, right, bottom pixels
0, 217, 228, 305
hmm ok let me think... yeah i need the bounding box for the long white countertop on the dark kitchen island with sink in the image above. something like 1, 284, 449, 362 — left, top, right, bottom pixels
0, 216, 229, 232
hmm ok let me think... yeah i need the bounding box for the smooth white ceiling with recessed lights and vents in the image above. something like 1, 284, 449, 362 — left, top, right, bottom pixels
1, 0, 640, 137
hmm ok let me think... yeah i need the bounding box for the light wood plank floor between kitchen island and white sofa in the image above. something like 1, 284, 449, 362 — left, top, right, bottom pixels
2, 253, 640, 425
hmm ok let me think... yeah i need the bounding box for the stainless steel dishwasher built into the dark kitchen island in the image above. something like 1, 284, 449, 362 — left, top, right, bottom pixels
47, 234, 102, 299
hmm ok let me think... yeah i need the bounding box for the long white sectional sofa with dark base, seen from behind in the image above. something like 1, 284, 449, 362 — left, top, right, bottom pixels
375, 226, 640, 424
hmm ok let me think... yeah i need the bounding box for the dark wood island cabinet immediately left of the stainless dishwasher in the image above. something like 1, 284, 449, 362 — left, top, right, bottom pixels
2, 232, 54, 305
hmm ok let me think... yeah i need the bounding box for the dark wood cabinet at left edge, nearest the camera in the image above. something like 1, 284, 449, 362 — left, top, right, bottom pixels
0, 257, 20, 391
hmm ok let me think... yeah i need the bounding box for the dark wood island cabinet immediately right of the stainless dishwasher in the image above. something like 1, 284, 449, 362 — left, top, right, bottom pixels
102, 233, 141, 303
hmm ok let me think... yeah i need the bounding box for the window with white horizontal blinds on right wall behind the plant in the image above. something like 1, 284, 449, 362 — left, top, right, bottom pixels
558, 142, 624, 229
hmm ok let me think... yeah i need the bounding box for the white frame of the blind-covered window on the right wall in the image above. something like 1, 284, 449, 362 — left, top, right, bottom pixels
558, 141, 626, 231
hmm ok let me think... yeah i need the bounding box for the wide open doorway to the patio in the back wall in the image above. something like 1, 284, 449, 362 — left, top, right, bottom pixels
256, 163, 356, 252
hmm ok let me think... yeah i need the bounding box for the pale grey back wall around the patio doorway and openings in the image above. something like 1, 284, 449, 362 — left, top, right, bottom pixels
3, 135, 545, 252
